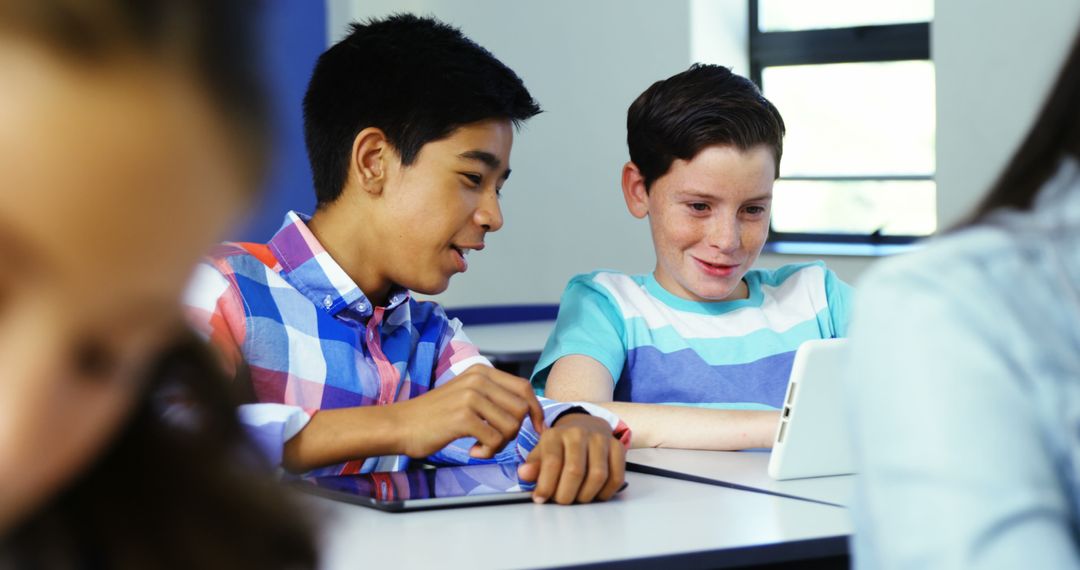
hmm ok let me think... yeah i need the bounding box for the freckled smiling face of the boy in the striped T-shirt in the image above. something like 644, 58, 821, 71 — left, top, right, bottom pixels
623, 145, 775, 301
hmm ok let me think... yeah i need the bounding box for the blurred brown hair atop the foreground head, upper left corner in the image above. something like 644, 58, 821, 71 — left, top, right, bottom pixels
0, 0, 270, 189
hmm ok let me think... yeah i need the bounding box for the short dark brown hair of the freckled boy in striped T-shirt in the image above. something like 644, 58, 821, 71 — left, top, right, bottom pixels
626, 64, 784, 189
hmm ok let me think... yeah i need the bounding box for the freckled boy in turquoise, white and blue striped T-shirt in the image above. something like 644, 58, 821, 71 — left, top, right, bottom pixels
532, 65, 852, 449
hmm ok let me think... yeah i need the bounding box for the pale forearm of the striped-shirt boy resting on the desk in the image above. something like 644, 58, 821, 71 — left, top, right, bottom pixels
597, 402, 780, 451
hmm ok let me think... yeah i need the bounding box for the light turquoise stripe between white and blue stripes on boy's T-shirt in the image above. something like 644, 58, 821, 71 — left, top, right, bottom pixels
625, 310, 831, 366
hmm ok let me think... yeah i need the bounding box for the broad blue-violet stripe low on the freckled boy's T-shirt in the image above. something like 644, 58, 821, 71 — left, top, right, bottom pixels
615, 347, 795, 408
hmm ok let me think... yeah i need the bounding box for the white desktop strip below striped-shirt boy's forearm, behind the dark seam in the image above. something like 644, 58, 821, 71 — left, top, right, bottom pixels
626, 448, 855, 506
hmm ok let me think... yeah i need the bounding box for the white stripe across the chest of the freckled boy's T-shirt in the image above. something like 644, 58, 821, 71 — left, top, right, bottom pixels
593, 266, 827, 339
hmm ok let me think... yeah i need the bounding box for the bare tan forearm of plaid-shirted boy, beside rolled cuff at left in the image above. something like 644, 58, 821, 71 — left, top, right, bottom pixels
282, 406, 402, 473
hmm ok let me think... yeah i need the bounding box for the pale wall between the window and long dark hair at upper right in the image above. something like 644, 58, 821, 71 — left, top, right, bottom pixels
931, 0, 1080, 228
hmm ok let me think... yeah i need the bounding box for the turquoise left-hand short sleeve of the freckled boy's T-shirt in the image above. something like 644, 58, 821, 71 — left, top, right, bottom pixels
532, 274, 626, 394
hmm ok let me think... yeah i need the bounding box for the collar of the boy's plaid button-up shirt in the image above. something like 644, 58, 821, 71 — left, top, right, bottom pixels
267, 212, 408, 318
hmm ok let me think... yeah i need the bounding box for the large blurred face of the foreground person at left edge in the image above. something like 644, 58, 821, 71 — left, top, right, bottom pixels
0, 41, 242, 534
